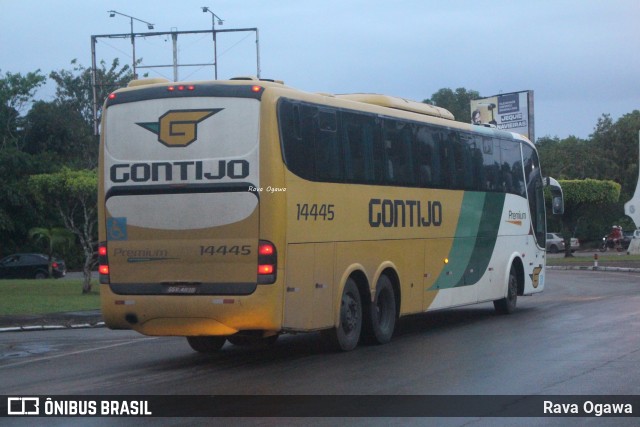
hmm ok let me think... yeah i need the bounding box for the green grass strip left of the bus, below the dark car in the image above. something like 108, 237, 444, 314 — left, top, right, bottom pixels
0, 279, 100, 316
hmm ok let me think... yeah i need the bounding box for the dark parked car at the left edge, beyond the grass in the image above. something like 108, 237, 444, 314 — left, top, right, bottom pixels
0, 254, 67, 279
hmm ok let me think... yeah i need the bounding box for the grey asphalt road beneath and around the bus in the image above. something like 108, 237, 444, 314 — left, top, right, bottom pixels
0, 271, 640, 426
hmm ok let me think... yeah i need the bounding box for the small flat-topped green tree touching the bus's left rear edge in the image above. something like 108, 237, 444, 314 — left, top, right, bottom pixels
29, 168, 98, 293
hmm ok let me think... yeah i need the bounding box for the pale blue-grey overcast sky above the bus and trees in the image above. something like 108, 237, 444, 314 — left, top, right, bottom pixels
0, 0, 640, 138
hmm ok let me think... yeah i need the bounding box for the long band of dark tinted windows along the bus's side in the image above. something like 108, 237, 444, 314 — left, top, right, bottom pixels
278, 98, 532, 199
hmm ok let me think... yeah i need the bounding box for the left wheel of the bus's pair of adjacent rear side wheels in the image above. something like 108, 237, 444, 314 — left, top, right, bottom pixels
323, 278, 362, 351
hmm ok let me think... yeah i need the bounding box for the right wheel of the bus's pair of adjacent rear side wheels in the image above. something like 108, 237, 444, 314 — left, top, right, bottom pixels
367, 276, 396, 344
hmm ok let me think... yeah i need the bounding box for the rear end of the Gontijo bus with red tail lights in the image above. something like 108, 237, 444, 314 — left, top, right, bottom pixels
99, 82, 281, 342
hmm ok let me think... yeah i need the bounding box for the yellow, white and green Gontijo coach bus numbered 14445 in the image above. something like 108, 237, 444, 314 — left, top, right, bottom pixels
99, 79, 562, 352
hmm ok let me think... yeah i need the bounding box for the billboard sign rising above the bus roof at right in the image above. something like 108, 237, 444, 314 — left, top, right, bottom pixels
471, 90, 535, 142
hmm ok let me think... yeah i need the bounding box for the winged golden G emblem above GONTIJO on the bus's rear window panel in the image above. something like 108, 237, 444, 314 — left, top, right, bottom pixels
136, 108, 223, 147
